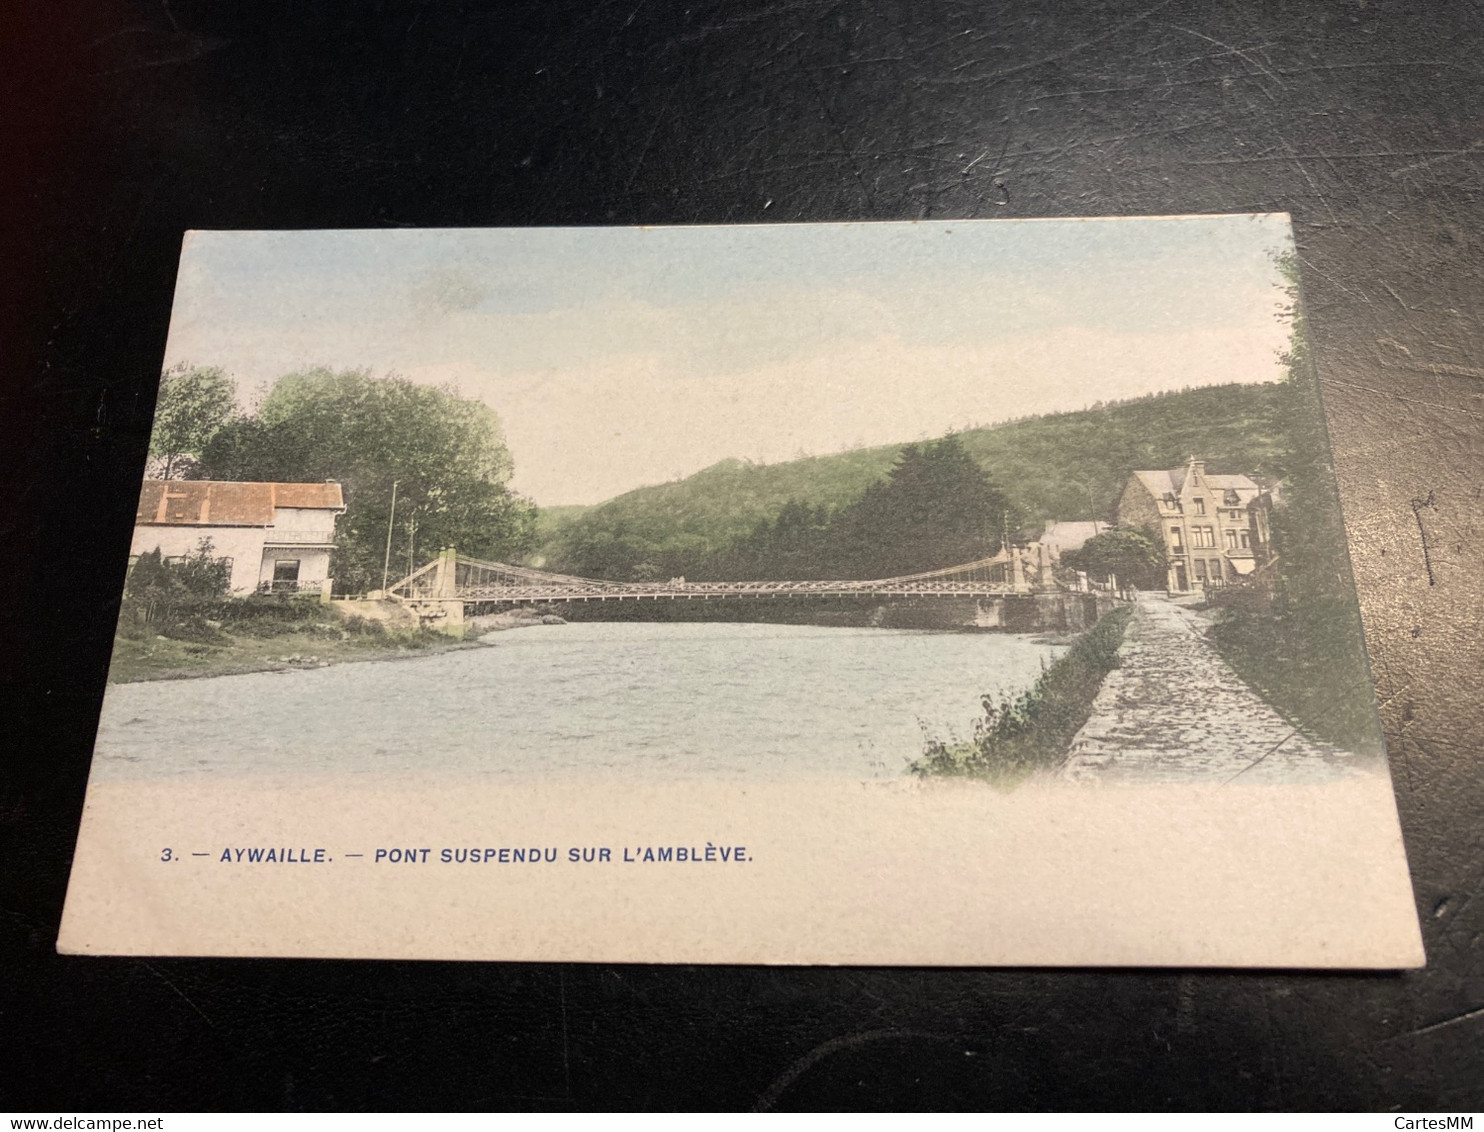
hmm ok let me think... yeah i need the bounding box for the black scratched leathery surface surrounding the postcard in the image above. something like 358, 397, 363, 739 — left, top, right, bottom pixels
0, 0, 1484, 1111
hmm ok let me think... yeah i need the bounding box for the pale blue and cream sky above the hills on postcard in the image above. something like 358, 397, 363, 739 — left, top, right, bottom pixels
165, 214, 1293, 506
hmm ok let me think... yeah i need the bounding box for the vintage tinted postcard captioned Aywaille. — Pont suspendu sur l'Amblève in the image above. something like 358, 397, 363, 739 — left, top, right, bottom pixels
59, 215, 1423, 967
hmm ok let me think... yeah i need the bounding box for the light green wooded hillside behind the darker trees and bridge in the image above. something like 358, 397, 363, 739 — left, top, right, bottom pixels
530, 383, 1285, 580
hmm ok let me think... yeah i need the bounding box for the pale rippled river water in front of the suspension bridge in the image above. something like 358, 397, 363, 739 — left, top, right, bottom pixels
93, 622, 1063, 780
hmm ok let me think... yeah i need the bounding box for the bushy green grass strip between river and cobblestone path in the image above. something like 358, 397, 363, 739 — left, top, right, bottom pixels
908, 607, 1132, 789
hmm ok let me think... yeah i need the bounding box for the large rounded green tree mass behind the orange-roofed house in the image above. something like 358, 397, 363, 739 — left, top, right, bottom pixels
197, 368, 536, 590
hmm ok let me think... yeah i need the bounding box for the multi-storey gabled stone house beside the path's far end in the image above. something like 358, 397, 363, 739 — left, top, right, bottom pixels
1117, 455, 1273, 593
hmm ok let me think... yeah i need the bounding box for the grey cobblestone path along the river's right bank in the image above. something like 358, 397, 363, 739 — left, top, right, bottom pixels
1060, 593, 1359, 783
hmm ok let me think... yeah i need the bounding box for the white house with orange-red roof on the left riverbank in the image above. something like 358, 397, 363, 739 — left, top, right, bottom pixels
129, 479, 346, 593
